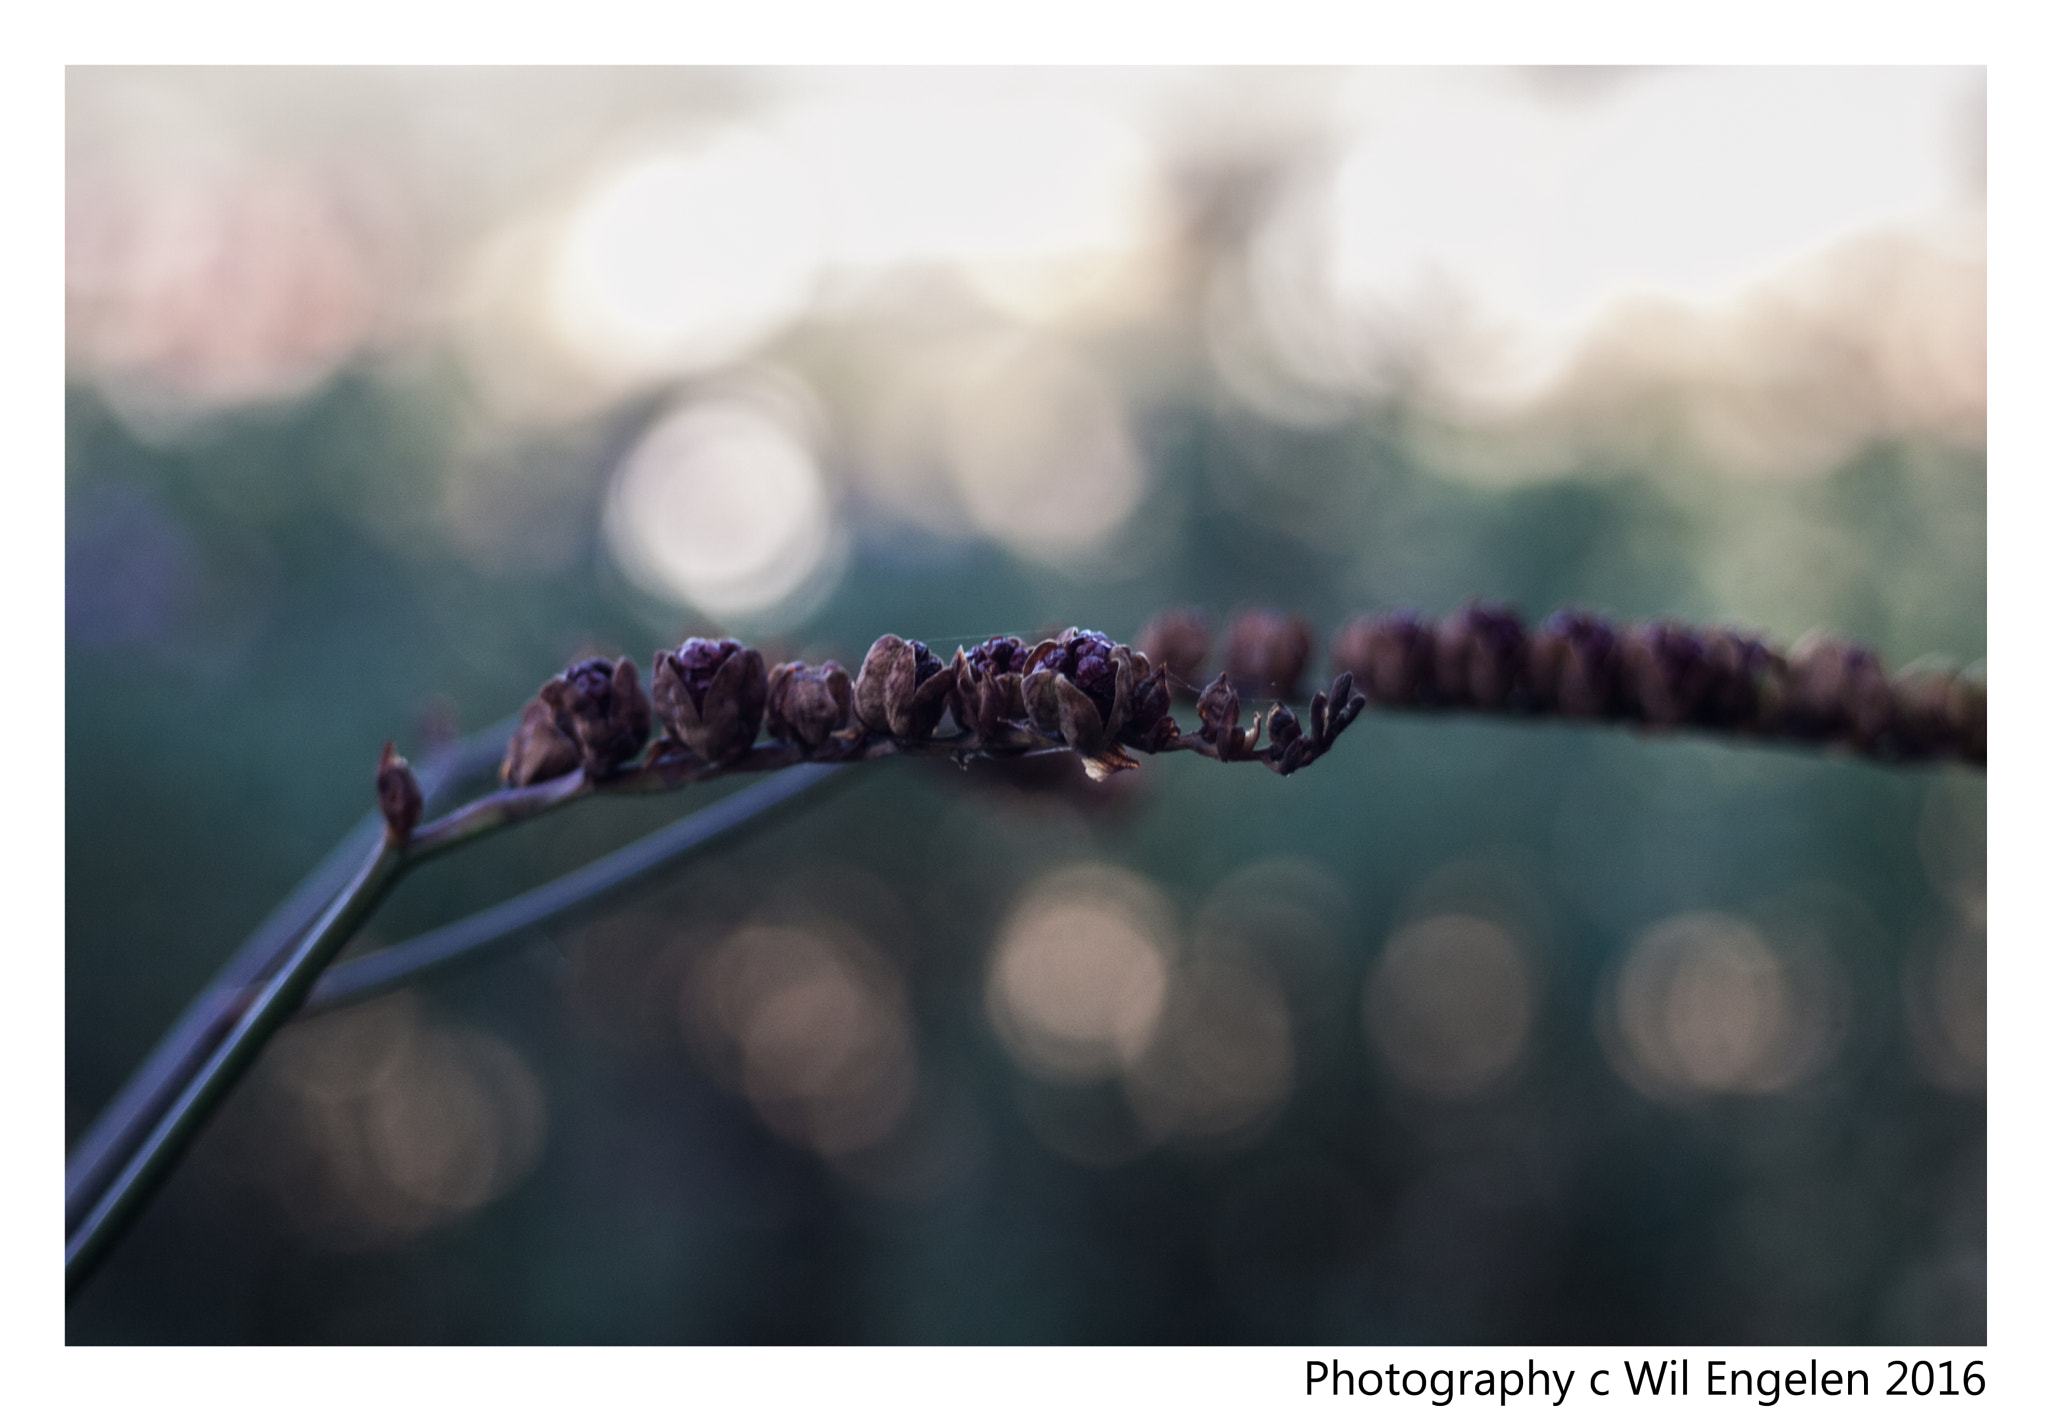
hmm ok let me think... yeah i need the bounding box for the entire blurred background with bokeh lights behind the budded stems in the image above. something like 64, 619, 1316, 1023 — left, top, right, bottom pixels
66, 70, 1985, 1343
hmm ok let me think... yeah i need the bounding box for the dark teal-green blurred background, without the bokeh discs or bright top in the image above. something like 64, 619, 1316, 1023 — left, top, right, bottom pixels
66, 362, 1985, 1343
